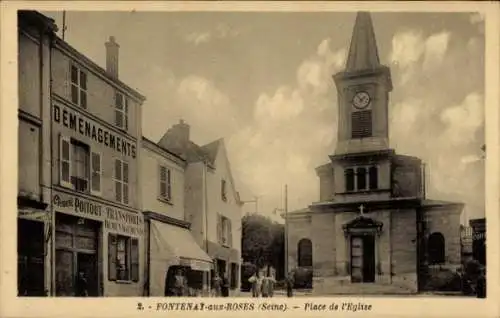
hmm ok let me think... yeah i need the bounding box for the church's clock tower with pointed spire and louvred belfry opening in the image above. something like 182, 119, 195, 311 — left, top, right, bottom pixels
333, 12, 392, 155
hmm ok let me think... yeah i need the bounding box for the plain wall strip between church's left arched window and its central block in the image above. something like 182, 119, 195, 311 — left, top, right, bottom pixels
311, 213, 336, 276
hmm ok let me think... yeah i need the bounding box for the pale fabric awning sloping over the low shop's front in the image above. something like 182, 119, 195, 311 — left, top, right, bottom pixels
150, 220, 213, 271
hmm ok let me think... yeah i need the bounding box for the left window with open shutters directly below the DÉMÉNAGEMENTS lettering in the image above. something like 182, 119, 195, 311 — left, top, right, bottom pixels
59, 136, 102, 195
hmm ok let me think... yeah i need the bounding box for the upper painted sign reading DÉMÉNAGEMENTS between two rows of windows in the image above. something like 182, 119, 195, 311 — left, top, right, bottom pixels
53, 105, 136, 158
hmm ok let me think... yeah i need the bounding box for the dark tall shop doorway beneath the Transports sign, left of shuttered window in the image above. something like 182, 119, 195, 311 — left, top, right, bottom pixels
55, 213, 102, 297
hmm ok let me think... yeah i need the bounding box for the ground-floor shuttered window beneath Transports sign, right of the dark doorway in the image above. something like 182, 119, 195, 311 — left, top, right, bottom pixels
108, 234, 139, 282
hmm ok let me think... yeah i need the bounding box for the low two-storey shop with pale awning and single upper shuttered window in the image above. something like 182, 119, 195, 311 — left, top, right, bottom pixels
141, 138, 213, 297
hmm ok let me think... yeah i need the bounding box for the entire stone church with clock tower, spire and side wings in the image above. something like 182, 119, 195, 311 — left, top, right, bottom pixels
286, 12, 463, 294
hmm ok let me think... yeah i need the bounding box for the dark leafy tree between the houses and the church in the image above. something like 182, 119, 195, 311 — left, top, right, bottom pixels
241, 214, 284, 276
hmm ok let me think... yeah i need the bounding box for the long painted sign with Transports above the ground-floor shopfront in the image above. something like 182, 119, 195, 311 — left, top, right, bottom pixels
52, 192, 144, 235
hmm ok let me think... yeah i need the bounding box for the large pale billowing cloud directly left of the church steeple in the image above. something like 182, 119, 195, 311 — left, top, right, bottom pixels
228, 39, 347, 213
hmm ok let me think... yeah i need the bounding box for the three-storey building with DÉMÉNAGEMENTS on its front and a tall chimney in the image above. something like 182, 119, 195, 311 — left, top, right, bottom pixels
50, 33, 145, 296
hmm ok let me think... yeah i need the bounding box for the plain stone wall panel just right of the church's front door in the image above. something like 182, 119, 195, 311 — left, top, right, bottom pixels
391, 209, 417, 289
